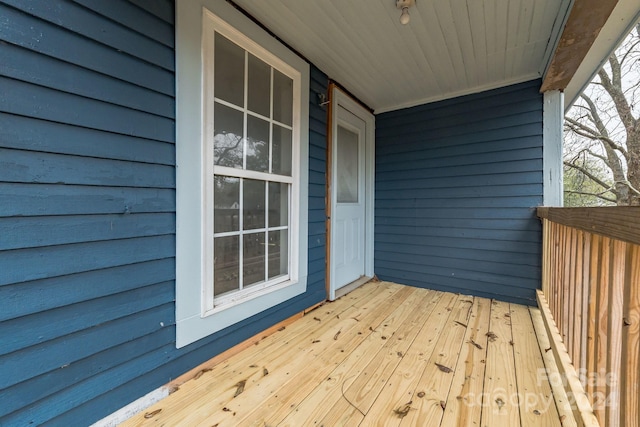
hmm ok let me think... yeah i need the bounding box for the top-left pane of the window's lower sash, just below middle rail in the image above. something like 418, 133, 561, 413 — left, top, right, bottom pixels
213, 175, 240, 233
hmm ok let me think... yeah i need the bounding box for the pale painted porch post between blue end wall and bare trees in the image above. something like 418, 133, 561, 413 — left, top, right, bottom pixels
542, 90, 564, 206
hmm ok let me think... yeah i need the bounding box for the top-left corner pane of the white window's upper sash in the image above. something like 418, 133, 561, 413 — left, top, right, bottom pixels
214, 33, 244, 107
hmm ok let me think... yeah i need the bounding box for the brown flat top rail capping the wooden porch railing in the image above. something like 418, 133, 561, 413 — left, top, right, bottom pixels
538, 206, 640, 245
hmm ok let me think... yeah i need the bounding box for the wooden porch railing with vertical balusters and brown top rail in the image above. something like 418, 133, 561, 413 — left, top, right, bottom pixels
538, 207, 640, 427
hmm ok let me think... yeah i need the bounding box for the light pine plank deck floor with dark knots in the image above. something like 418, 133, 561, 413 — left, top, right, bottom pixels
124, 282, 573, 427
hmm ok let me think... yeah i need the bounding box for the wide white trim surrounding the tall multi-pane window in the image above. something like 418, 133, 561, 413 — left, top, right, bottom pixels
176, 0, 309, 348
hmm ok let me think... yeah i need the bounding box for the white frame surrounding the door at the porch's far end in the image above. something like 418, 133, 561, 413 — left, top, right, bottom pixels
325, 83, 375, 301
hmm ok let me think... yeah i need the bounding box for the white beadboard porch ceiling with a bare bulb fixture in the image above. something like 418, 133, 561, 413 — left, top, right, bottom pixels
234, 0, 571, 112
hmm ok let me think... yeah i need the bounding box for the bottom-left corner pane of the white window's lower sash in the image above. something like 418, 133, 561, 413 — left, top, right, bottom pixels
213, 236, 240, 296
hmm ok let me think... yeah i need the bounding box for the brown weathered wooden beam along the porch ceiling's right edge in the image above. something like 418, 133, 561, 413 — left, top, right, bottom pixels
540, 0, 618, 92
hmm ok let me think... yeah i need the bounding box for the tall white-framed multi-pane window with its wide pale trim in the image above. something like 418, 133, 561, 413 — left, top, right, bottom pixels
176, 0, 309, 347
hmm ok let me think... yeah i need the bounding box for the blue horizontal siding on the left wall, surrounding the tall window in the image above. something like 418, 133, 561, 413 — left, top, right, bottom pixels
0, 0, 327, 425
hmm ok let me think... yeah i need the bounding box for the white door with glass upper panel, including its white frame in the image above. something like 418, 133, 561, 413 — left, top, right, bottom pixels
329, 87, 373, 299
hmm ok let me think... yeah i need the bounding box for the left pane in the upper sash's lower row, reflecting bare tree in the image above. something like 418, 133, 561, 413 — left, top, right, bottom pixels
213, 102, 243, 169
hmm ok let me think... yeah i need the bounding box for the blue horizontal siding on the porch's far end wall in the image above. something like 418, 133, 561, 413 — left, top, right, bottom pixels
375, 80, 543, 304
